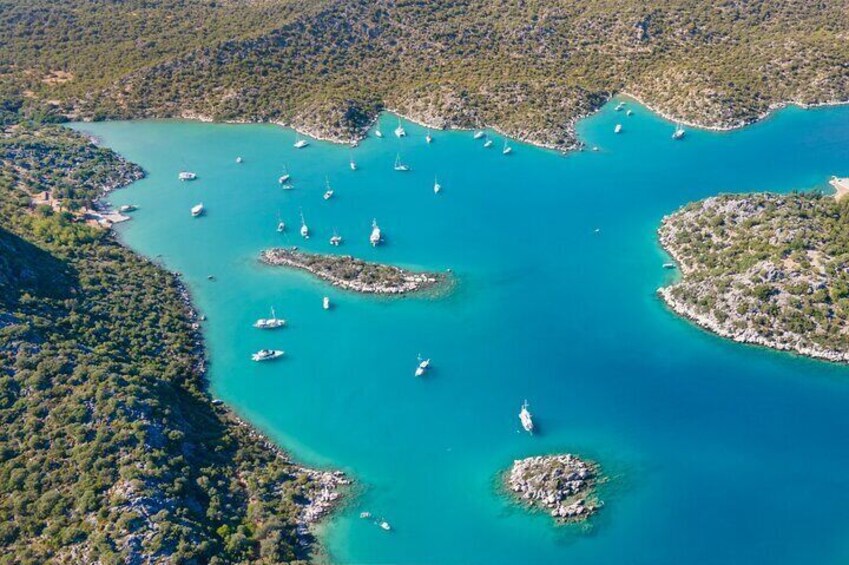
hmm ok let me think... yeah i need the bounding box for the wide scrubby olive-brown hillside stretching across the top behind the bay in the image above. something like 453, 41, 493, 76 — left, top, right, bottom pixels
0, 0, 849, 149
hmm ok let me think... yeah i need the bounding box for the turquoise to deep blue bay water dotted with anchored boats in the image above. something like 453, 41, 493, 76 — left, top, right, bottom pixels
76, 103, 849, 564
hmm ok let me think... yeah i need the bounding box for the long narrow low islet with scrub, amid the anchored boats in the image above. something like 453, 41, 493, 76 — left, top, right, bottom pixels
260, 248, 446, 294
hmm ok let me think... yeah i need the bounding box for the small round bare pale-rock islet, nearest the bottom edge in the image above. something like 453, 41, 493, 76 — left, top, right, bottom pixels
505, 453, 602, 524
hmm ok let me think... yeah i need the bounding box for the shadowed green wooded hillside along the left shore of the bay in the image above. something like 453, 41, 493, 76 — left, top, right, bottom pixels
0, 112, 344, 564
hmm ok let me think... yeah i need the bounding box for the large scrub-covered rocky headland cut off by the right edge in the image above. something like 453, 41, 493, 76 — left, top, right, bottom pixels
658, 193, 849, 362
